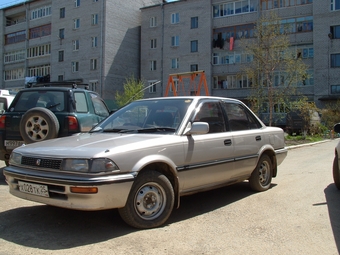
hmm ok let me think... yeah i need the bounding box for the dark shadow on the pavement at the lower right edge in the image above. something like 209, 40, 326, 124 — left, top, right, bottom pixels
324, 183, 340, 254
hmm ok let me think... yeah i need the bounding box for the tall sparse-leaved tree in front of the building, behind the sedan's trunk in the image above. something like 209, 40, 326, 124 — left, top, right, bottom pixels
242, 12, 308, 126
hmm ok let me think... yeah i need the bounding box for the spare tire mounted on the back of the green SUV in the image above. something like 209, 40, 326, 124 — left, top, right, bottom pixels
20, 107, 59, 144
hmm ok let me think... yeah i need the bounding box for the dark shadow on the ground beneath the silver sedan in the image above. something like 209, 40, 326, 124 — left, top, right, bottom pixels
0, 182, 274, 250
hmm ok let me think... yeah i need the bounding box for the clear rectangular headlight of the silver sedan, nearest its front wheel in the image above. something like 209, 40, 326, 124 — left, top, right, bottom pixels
63, 158, 119, 173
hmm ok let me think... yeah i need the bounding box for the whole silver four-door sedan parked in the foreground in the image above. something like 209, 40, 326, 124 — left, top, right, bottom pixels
4, 96, 287, 228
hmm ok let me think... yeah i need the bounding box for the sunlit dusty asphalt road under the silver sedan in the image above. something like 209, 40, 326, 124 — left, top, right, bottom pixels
0, 140, 340, 255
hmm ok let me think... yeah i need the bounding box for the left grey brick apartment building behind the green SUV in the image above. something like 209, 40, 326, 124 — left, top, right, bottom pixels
0, 0, 154, 99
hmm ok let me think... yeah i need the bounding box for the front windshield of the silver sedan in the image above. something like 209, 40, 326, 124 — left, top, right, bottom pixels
91, 98, 192, 133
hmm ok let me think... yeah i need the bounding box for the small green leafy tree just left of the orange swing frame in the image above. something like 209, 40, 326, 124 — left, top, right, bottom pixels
116, 75, 144, 107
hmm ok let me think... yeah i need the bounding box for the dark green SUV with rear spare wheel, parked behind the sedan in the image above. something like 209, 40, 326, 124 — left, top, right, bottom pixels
0, 87, 109, 164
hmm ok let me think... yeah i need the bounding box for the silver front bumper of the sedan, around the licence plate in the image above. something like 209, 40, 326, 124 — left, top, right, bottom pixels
3, 166, 136, 211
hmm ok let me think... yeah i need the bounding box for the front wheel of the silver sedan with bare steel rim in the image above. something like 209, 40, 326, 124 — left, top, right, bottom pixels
118, 171, 175, 229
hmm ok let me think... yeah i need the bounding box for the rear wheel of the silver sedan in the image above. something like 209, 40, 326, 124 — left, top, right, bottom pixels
249, 154, 273, 192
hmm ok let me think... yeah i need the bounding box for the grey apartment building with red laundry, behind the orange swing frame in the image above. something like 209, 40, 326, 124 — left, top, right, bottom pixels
141, 0, 340, 123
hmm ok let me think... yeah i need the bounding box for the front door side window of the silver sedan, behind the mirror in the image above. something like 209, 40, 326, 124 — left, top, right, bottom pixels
194, 102, 226, 133
